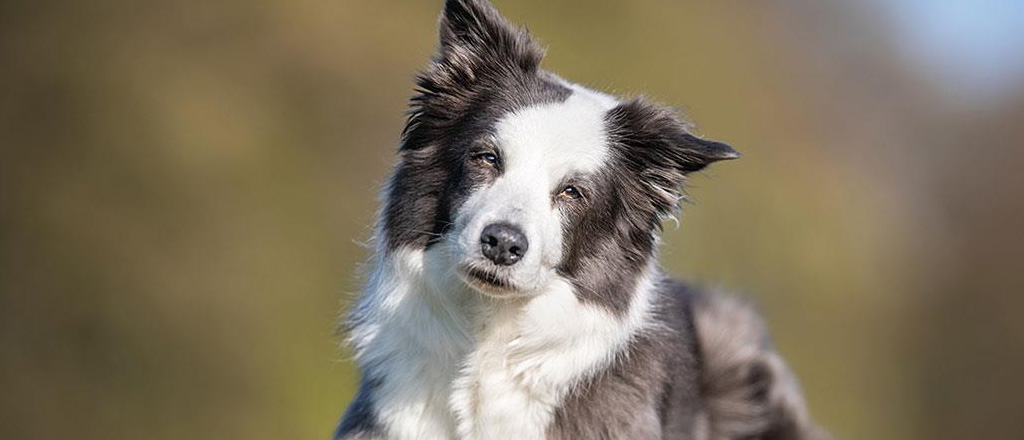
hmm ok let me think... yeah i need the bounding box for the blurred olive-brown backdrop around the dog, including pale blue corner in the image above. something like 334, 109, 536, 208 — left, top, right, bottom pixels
0, 0, 1024, 440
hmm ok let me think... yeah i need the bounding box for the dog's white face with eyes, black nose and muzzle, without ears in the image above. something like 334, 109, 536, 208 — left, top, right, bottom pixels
445, 86, 615, 296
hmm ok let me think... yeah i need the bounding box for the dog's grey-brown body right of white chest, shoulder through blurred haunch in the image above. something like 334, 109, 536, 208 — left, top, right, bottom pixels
549, 279, 828, 440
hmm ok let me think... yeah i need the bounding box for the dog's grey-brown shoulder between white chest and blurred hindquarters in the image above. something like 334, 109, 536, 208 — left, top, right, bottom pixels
548, 278, 701, 439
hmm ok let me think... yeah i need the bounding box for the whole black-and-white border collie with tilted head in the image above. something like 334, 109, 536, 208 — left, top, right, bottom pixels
334, 0, 827, 440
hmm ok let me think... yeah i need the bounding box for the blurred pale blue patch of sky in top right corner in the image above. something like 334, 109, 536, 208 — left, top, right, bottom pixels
874, 0, 1024, 98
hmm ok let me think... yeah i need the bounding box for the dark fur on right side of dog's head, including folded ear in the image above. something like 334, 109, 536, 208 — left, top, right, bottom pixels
558, 100, 738, 314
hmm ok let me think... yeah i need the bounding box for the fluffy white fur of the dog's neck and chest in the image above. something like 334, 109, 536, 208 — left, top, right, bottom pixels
351, 252, 652, 440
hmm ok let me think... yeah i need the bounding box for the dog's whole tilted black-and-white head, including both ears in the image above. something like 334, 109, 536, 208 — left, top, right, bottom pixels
381, 0, 738, 309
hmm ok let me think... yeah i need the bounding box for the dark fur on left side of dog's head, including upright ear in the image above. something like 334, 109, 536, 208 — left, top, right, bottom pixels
382, 2, 571, 251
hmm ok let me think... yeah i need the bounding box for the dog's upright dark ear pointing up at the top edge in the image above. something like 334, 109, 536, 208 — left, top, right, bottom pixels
434, 0, 544, 82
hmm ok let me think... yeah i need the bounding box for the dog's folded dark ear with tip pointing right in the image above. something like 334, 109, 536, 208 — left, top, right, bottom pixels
606, 99, 739, 216
